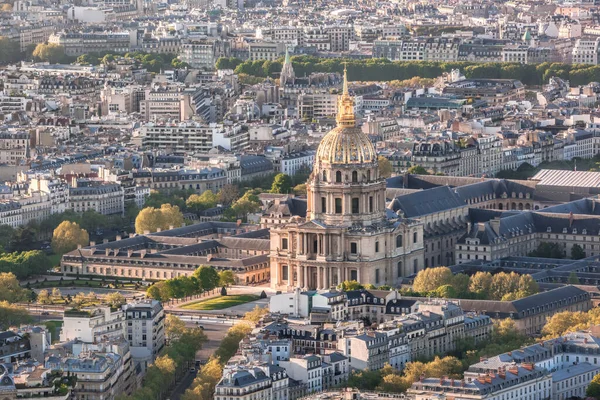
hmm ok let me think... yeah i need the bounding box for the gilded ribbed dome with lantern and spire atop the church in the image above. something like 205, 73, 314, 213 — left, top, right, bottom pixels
316, 68, 377, 164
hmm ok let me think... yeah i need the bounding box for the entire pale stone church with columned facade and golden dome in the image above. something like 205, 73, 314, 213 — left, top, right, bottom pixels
263, 71, 423, 291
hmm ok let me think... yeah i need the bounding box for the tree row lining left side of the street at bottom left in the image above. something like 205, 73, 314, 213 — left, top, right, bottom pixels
117, 315, 207, 400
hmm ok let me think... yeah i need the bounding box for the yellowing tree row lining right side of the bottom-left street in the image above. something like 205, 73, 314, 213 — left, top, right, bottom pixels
182, 306, 268, 400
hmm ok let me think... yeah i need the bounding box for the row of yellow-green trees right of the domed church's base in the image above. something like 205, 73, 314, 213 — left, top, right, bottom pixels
413, 267, 539, 301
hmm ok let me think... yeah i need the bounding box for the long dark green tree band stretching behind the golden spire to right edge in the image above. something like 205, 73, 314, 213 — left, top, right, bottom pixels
221, 55, 600, 85
